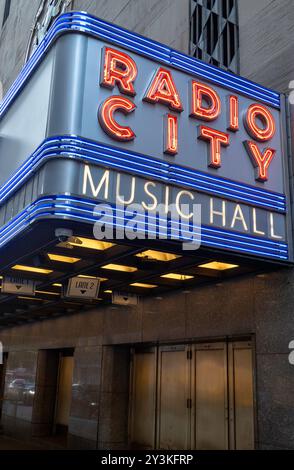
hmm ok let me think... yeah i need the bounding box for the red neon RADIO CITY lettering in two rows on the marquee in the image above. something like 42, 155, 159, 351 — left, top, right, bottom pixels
98, 47, 276, 182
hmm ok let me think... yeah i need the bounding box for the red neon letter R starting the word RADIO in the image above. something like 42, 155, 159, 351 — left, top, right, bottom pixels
100, 47, 137, 96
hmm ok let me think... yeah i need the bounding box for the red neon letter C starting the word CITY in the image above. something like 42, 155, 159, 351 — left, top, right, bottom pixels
98, 96, 136, 141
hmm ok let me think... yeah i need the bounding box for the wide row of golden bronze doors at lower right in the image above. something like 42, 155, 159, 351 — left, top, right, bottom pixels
129, 341, 254, 450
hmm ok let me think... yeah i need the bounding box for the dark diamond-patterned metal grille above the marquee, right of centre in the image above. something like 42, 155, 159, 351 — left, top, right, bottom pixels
190, 0, 239, 73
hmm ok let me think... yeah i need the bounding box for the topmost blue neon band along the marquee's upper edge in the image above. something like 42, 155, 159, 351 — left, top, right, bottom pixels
0, 12, 280, 123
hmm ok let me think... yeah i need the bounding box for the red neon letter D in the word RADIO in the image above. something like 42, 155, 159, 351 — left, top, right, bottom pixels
190, 80, 221, 121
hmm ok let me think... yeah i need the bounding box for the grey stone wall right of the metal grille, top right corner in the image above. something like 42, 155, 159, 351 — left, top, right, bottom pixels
238, 0, 294, 92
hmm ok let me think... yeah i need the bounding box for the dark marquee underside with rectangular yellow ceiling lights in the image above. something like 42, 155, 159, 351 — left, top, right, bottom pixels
0, 220, 284, 328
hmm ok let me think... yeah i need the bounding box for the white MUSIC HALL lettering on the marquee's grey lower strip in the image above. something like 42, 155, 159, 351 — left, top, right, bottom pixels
81, 165, 285, 240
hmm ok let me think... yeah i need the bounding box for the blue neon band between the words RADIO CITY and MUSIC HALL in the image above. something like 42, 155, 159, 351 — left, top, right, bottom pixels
0, 136, 286, 213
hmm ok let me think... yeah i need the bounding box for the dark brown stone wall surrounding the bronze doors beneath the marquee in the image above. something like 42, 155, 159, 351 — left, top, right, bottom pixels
0, 269, 294, 449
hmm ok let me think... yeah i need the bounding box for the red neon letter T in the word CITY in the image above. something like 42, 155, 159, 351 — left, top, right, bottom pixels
198, 126, 230, 168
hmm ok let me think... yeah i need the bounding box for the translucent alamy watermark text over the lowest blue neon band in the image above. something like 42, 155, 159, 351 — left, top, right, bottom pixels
93, 203, 201, 250
